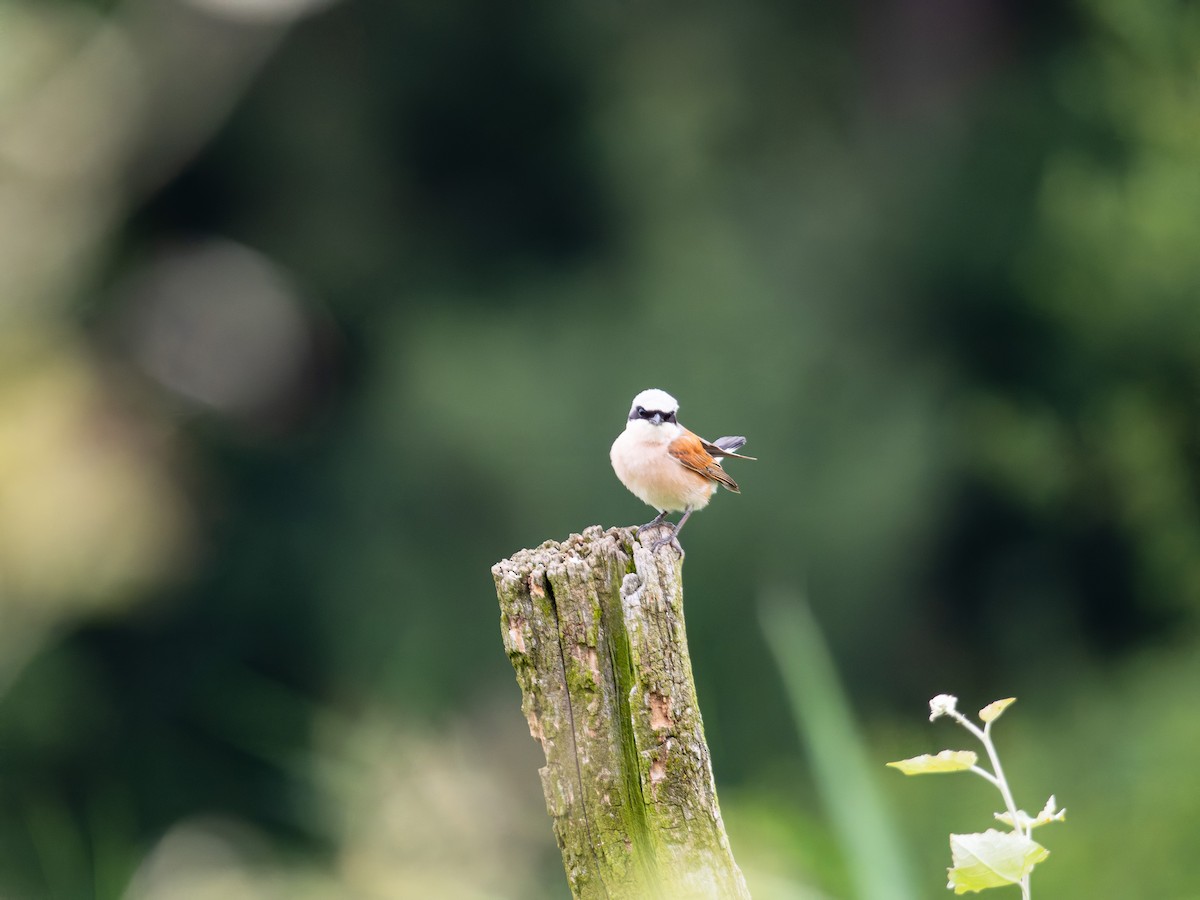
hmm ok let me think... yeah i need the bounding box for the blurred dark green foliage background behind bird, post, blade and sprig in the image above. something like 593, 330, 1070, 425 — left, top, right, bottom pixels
0, 0, 1200, 900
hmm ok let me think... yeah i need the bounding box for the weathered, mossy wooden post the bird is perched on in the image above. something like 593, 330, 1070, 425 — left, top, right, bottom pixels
492, 526, 750, 900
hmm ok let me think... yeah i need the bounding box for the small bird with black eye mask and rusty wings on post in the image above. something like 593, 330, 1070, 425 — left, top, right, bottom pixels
608, 388, 754, 553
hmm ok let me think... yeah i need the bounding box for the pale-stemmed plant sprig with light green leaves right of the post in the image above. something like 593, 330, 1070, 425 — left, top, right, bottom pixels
888, 694, 1067, 900
